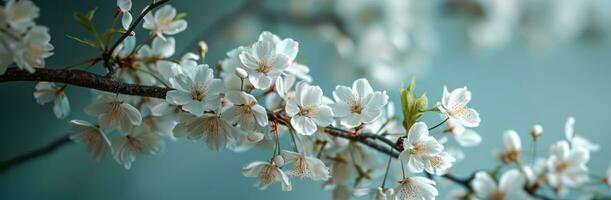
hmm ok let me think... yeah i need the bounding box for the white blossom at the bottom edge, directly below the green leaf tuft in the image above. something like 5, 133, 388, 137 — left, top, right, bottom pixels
393, 176, 439, 200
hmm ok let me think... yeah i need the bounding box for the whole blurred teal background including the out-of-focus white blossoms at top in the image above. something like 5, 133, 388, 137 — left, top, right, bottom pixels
0, 0, 611, 199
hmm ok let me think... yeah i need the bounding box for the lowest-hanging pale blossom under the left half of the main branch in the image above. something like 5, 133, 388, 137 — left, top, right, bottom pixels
112, 126, 164, 169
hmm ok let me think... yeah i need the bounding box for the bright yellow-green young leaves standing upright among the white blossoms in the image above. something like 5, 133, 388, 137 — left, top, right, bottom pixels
401, 77, 428, 132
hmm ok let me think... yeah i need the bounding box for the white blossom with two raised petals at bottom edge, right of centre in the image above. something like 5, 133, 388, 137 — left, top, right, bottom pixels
471, 169, 528, 199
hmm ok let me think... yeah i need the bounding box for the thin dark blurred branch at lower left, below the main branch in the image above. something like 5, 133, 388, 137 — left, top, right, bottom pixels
0, 136, 70, 172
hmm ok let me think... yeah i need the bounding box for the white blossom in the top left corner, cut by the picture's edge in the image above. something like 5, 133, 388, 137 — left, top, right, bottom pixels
0, 0, 40, 34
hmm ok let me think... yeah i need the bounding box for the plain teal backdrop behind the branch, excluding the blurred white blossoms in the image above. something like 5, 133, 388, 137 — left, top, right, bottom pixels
0, 0, 611, 199
